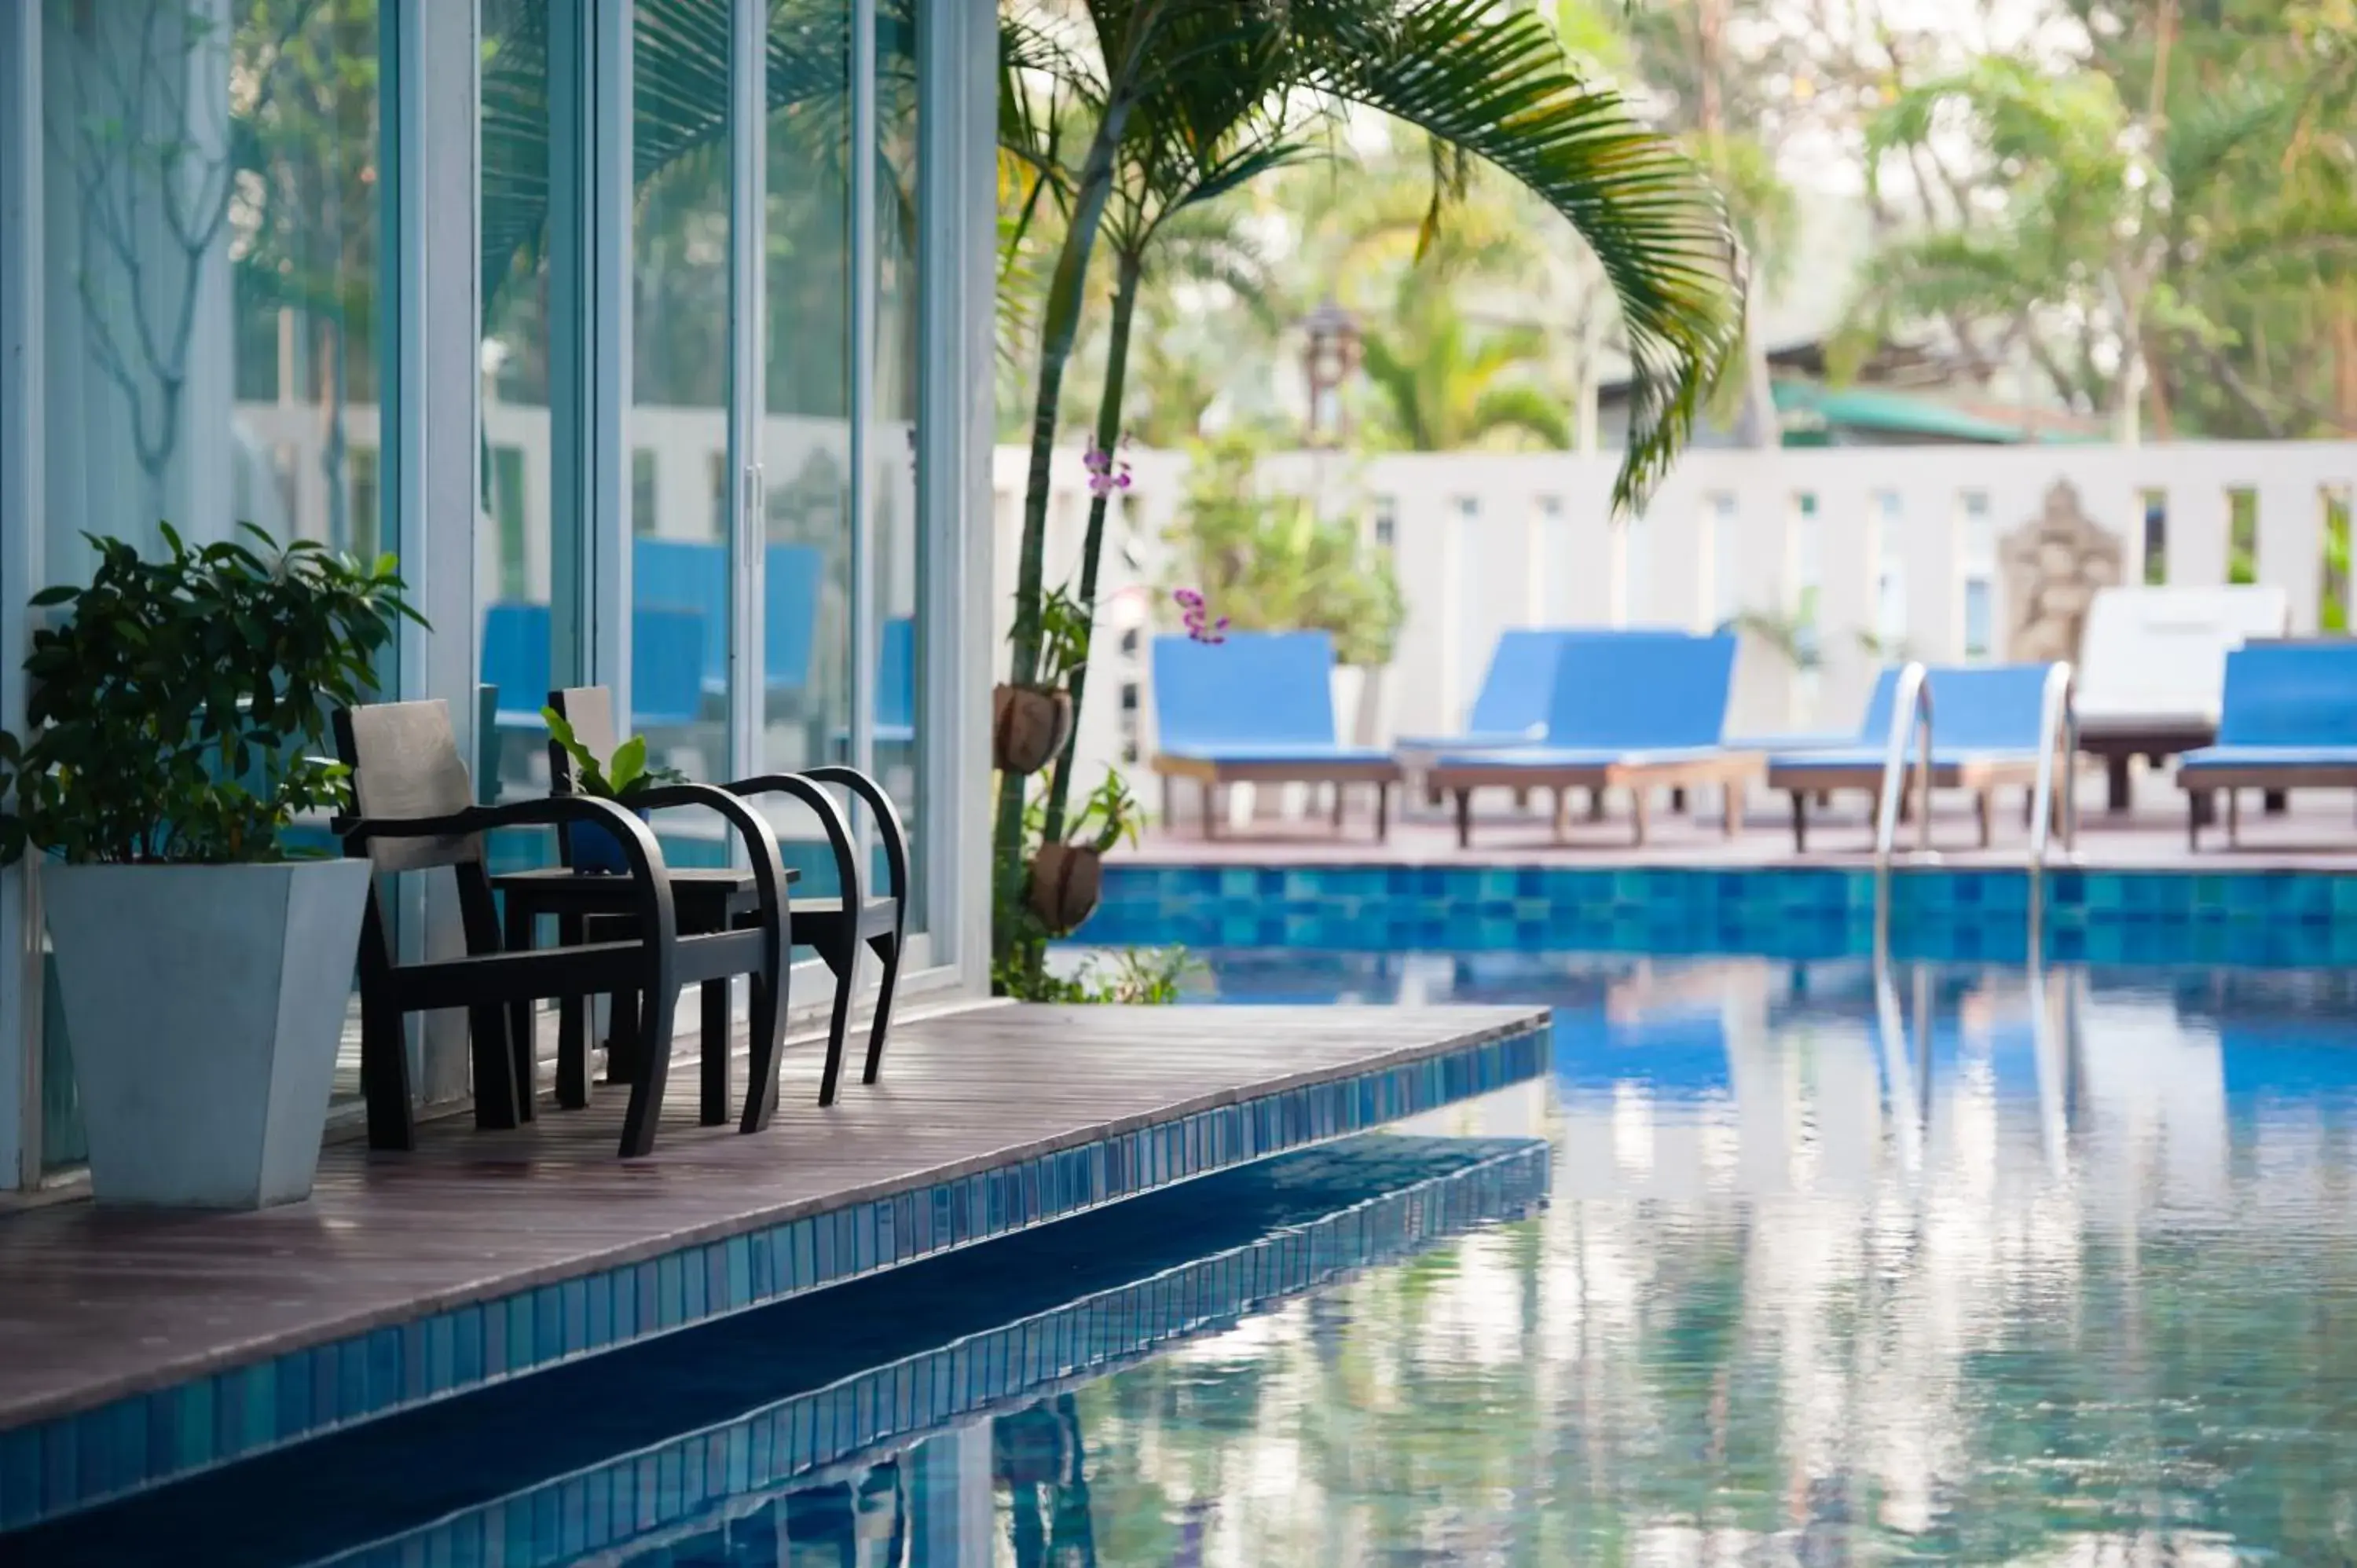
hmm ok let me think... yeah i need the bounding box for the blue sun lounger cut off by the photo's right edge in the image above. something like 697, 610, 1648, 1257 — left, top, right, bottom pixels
2178, 639, 2357, 849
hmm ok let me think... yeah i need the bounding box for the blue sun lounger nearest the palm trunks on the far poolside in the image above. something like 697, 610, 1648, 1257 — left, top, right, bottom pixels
1153, 632, 1400, 840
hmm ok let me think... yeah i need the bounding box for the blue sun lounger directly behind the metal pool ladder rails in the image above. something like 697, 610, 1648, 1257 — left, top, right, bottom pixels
1768, 665, 2067, 852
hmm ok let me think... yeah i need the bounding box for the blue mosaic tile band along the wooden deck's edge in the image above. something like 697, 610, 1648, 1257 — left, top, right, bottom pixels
0, 1009, 1549, 1518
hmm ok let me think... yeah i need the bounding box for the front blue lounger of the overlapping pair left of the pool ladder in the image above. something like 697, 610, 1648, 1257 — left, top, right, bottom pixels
1424, 632, 1758, 847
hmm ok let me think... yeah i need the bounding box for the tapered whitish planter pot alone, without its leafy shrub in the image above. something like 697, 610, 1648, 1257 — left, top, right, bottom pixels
40, 861, 370, 1210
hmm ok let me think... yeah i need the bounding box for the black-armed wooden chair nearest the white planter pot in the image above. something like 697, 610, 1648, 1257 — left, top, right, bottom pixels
335, 700, 787, 1158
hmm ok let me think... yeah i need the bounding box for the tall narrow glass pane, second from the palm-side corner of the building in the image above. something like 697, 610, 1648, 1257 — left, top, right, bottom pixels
761, 0, 851, 896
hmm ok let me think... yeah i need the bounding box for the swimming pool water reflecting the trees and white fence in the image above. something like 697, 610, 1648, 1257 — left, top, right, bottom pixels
18, 933, 2357, 1568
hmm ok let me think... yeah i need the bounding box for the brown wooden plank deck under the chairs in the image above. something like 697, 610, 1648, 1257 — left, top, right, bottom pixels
0, 1007, 1544, 1429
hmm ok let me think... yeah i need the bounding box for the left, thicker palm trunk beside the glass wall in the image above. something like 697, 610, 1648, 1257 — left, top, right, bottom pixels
990, 76, 1150, 960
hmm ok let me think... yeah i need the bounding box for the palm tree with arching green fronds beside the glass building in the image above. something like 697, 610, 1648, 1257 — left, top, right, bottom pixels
995, 0, 1739, 980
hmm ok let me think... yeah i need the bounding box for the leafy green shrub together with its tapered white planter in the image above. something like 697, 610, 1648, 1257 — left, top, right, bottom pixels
0, 528, 422, 1207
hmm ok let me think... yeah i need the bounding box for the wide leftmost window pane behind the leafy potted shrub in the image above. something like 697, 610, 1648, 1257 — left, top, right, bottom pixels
40, 0, 389, 1163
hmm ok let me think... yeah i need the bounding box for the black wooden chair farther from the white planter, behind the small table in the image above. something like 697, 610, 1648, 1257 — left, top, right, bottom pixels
549, 686, 907, 1112
